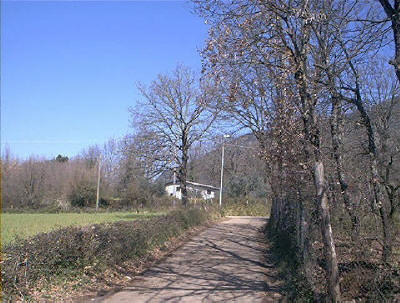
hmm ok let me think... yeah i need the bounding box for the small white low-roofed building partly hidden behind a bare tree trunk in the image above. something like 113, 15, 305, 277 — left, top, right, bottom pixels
165, 181, 219, 200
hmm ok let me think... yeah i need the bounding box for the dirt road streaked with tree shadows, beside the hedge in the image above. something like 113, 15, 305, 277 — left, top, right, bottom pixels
95, 217, 281, 302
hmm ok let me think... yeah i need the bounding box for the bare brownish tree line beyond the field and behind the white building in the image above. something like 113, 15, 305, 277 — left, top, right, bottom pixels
1, 131, 268, 211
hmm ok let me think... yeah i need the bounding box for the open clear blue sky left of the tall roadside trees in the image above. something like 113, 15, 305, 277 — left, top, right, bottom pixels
1, 0, 207, 158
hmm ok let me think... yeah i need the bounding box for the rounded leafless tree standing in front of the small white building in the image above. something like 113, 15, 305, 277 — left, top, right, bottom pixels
130, 65, 218, 206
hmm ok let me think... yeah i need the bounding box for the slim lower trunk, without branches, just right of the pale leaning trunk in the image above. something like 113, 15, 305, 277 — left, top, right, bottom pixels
330, 97, 360, 242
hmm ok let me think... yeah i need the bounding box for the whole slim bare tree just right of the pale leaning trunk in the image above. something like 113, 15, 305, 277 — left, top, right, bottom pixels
311, 0, 384, 241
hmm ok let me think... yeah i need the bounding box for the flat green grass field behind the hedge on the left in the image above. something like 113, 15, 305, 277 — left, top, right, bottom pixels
1, 212, 163, 245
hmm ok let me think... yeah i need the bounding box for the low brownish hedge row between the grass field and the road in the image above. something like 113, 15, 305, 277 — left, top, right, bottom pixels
1, 209, 216, 300
